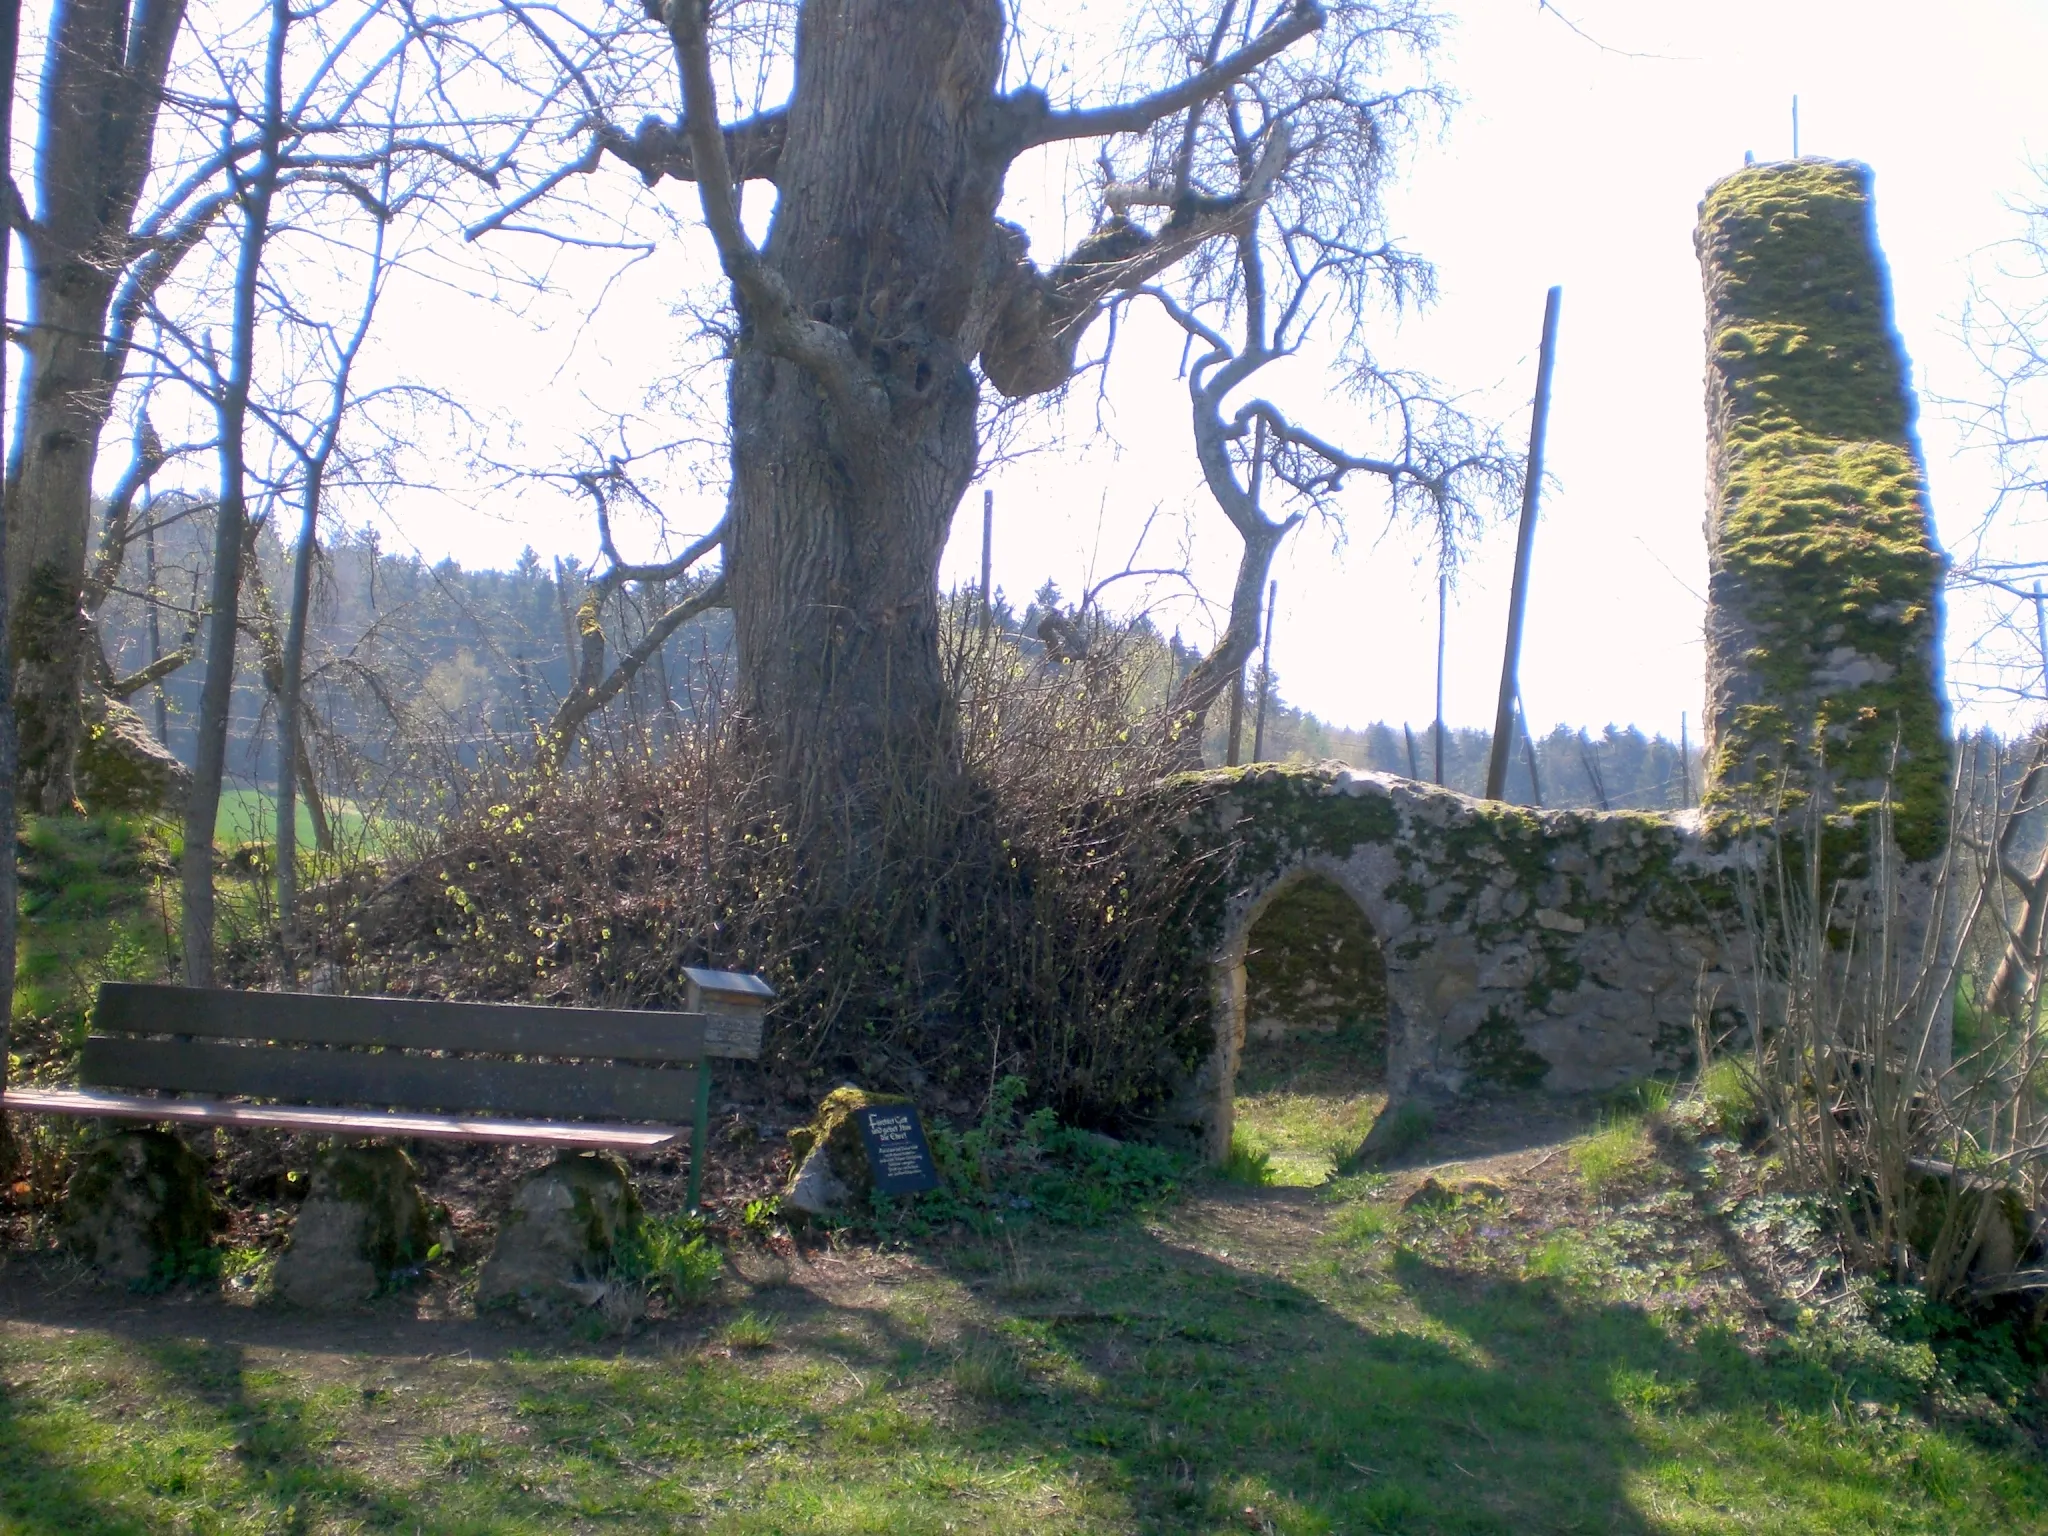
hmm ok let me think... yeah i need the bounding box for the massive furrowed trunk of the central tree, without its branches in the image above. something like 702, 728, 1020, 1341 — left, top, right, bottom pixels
727, 0, 1004, 856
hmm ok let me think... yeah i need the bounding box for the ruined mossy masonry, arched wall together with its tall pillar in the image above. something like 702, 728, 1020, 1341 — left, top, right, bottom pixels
1171, 160, 1950, 1157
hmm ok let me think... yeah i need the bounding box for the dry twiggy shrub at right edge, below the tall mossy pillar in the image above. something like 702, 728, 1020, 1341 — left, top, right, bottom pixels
1720, 760, 2048, 1303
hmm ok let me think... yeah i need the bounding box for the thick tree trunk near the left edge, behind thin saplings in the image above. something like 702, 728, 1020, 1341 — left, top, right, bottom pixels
6, 0, 184, 811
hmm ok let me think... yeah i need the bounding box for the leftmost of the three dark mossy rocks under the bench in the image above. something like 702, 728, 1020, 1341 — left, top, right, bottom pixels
61, 1128, 223, 1284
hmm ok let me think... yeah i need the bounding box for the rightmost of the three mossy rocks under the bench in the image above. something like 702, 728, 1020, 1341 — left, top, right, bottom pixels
477, 1153, 638, 1321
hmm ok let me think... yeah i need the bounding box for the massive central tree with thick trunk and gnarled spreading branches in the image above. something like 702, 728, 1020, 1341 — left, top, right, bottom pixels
473, 0, 1368, 909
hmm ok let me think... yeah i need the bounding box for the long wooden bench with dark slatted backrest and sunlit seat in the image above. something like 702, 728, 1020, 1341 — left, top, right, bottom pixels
4, 969, 774, 1210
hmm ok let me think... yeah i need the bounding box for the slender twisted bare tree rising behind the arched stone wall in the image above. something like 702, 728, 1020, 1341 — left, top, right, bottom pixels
1102, 2, 1518, 766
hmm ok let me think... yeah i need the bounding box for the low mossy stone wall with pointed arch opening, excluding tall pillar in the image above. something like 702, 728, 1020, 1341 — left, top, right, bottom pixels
1178, 764, 1755, 1155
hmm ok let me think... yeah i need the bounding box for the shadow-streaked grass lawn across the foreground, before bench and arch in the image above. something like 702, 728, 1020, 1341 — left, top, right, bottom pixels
0, 1089, 2048, 1536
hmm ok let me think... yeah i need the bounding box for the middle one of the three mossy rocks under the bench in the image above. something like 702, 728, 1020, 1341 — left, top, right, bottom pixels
276, 1147, 434, 1309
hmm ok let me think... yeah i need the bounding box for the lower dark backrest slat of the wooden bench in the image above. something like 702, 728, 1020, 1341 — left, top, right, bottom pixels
78, 1034, 696, 1120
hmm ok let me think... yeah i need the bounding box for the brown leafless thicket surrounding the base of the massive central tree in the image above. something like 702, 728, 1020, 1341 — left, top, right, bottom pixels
315, 612, 1210, 1124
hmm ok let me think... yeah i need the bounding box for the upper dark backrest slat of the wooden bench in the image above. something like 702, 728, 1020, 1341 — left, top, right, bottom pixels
92, 981, 760, 1064
